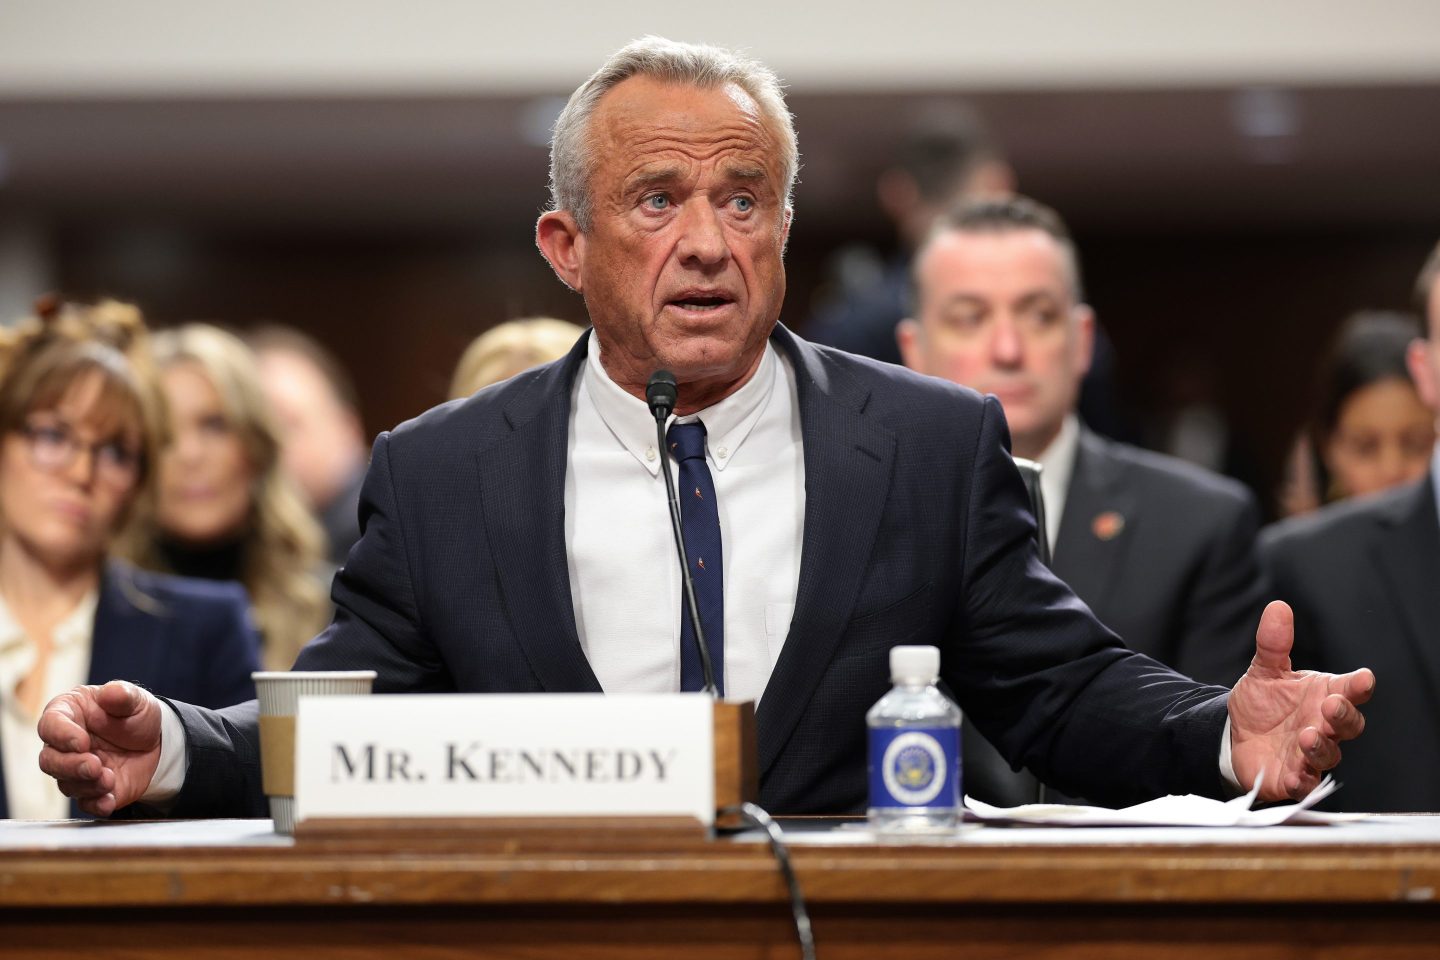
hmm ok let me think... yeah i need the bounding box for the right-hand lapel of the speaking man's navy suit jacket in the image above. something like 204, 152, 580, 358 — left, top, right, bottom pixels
757, 327, 896, 776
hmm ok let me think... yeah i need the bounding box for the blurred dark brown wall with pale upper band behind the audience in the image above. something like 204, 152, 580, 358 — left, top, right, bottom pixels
0, 0, 1440, 515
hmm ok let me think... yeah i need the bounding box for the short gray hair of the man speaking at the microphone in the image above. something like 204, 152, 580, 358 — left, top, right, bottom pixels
550, 36, 799, 230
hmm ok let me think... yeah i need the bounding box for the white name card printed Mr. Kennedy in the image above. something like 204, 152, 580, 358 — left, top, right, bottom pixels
295, 694, 716, 825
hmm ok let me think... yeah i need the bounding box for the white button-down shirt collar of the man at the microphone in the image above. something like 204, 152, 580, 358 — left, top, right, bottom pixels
582, 332, 780, 475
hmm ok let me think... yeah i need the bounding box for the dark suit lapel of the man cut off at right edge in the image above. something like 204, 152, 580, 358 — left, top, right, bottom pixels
1374, 475, 1440, 705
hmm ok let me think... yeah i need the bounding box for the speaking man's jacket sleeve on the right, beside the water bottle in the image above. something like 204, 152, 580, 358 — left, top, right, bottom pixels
946, 397, 1227, 805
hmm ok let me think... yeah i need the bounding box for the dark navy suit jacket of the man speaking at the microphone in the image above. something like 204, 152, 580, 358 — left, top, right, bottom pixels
165, 328, 1225, 816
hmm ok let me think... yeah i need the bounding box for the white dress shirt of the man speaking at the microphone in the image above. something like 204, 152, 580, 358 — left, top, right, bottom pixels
564, 335, 805, 701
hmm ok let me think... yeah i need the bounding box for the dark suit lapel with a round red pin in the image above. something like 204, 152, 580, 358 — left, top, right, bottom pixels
1051, 427, 1139, 609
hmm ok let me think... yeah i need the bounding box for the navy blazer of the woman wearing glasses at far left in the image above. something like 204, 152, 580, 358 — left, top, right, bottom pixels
0, 563, 259, 818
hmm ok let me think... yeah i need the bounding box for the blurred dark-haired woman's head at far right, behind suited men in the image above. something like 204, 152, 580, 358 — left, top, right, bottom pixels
1282, 311, 1436, 515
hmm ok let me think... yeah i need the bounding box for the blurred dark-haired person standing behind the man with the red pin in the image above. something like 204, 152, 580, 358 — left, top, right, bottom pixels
805, 102, 1015, 363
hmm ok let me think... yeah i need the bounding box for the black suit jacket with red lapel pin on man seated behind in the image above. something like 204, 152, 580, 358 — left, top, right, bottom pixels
1051, 429, 1269, 687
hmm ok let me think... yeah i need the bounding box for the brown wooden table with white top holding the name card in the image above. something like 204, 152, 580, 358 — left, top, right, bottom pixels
0, 816, 1440, 960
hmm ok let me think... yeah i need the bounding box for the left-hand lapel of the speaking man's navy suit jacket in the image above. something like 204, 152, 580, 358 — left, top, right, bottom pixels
477, 337, 600, 692
